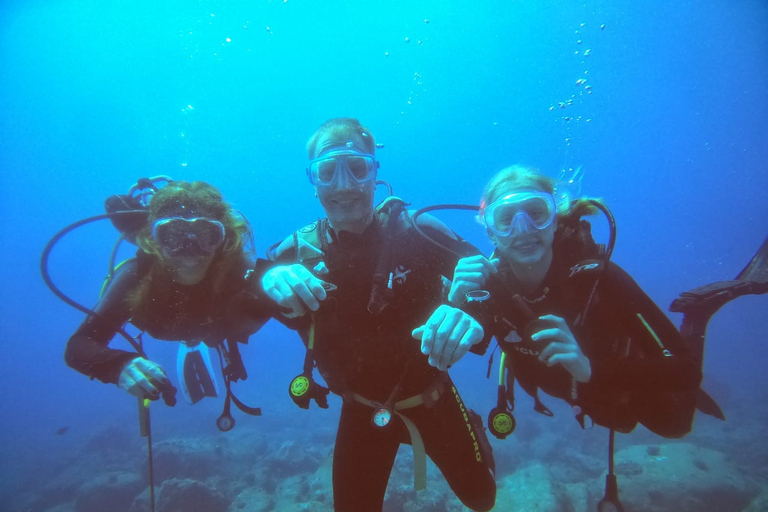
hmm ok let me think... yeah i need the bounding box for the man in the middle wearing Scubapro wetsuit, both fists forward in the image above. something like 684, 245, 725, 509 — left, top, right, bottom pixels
262, 118, 496, 512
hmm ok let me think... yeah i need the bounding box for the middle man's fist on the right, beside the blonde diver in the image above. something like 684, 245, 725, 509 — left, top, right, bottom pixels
411, 305, 485, 371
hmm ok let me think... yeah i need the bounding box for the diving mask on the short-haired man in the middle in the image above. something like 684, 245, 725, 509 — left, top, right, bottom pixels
307, 143, 379, 188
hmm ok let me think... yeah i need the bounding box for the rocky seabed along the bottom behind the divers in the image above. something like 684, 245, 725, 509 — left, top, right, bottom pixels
0, 388, 768, 512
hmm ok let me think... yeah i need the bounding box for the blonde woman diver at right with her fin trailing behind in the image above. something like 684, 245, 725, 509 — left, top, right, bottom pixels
438, 166, 768, 512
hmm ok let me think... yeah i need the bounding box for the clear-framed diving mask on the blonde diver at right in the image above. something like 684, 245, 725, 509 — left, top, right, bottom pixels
479, 191, 557, 236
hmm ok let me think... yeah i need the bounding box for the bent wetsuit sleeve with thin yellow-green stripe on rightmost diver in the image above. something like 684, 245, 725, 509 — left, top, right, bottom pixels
587, 264, 701, 393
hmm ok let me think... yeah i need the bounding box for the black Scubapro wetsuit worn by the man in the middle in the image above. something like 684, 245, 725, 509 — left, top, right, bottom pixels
277, 213, 496, 512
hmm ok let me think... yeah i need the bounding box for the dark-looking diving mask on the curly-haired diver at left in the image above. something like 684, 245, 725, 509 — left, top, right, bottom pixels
152, 217, 226, 256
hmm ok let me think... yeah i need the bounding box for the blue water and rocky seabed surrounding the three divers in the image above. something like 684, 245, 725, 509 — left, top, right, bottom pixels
0, 0, 768, 512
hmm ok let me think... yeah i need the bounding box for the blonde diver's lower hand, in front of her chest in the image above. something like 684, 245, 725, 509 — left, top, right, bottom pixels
531, 315, 592, 382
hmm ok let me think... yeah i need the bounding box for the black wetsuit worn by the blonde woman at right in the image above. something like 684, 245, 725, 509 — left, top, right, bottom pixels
483, 233, 702, 437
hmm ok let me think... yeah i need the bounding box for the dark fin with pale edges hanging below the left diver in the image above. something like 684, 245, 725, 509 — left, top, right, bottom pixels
176, 342, 219, 404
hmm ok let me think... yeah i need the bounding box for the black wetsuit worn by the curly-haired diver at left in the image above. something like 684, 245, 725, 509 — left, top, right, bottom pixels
64, 252, 269, 384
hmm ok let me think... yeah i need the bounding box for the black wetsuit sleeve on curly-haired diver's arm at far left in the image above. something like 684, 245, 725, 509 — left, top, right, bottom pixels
64, 260, 139, 384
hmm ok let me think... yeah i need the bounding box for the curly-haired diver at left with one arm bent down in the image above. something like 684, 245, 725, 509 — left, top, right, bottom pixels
54, 177, 270, 430
